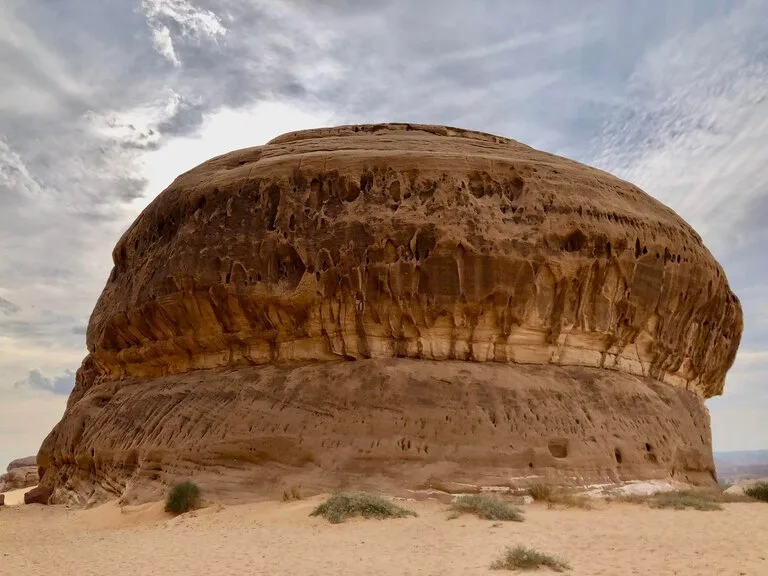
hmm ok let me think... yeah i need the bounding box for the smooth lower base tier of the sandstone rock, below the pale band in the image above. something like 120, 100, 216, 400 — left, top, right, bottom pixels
38, 359, 715, 503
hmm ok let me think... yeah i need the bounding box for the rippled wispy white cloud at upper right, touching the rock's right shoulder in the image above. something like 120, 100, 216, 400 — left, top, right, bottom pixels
596, 2, 768, 251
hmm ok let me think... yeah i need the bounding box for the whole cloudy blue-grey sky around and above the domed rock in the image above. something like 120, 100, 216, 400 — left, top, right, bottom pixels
0, 0, 768, 468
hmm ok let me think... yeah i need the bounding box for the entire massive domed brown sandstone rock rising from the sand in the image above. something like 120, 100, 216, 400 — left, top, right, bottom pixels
38, 125, 742, 500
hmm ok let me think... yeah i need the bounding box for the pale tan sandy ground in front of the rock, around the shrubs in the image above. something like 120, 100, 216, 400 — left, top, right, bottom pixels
0, 498, 768, 576
